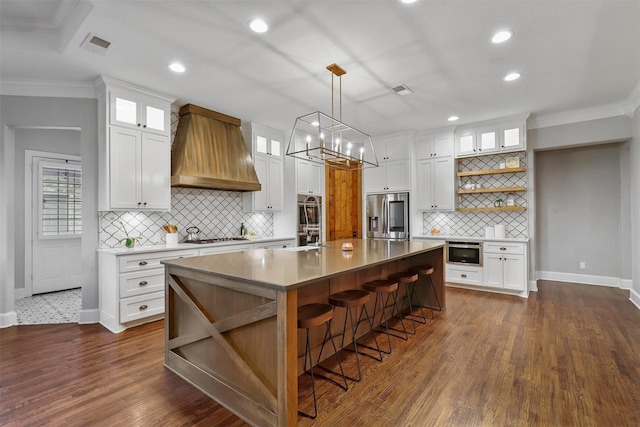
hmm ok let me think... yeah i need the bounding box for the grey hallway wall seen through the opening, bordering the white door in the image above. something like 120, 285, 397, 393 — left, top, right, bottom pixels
13, 129, 80, 289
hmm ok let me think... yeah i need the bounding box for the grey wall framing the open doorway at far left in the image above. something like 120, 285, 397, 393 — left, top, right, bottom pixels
0, 96, 98, 327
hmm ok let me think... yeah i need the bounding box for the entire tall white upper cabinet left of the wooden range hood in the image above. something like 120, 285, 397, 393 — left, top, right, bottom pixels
96, 76, 174, 211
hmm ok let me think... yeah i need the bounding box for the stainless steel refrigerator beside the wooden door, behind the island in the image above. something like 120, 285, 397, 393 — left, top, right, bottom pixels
367, 193, 409, 240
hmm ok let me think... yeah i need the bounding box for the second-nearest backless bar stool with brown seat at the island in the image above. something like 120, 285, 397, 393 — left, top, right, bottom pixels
330, 289, 382, 382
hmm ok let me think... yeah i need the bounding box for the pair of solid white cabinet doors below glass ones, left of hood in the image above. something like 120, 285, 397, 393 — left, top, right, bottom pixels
105, 126, 171, 211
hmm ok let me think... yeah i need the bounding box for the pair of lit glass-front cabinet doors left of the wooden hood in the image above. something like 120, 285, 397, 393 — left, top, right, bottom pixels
109, 89, 171, 135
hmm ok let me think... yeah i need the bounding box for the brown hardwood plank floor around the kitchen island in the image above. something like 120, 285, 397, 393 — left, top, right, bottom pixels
0, 282, 640, 427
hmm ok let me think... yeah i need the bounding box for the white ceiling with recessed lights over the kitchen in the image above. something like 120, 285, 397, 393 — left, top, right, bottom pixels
0, 0, 640, 135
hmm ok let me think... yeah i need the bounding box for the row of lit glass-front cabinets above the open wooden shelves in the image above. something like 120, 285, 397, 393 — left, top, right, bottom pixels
454, 118, 527, 158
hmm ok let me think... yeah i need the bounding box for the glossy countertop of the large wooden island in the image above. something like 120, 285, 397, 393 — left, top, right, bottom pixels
162, 239, 445, 288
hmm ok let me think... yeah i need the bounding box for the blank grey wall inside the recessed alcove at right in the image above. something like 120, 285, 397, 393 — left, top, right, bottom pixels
535, 144, 630, 279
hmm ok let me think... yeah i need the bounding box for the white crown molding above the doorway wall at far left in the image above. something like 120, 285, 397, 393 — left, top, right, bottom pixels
0, 80, 96, 98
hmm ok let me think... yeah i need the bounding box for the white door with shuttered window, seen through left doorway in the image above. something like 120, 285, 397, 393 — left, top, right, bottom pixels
31, 158, 82, 294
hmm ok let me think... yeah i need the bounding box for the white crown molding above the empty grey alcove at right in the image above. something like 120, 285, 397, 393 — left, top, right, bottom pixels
527, 100, 633, 129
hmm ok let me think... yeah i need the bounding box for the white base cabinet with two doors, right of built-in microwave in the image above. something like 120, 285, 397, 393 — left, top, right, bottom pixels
483, 242, 526, 291
